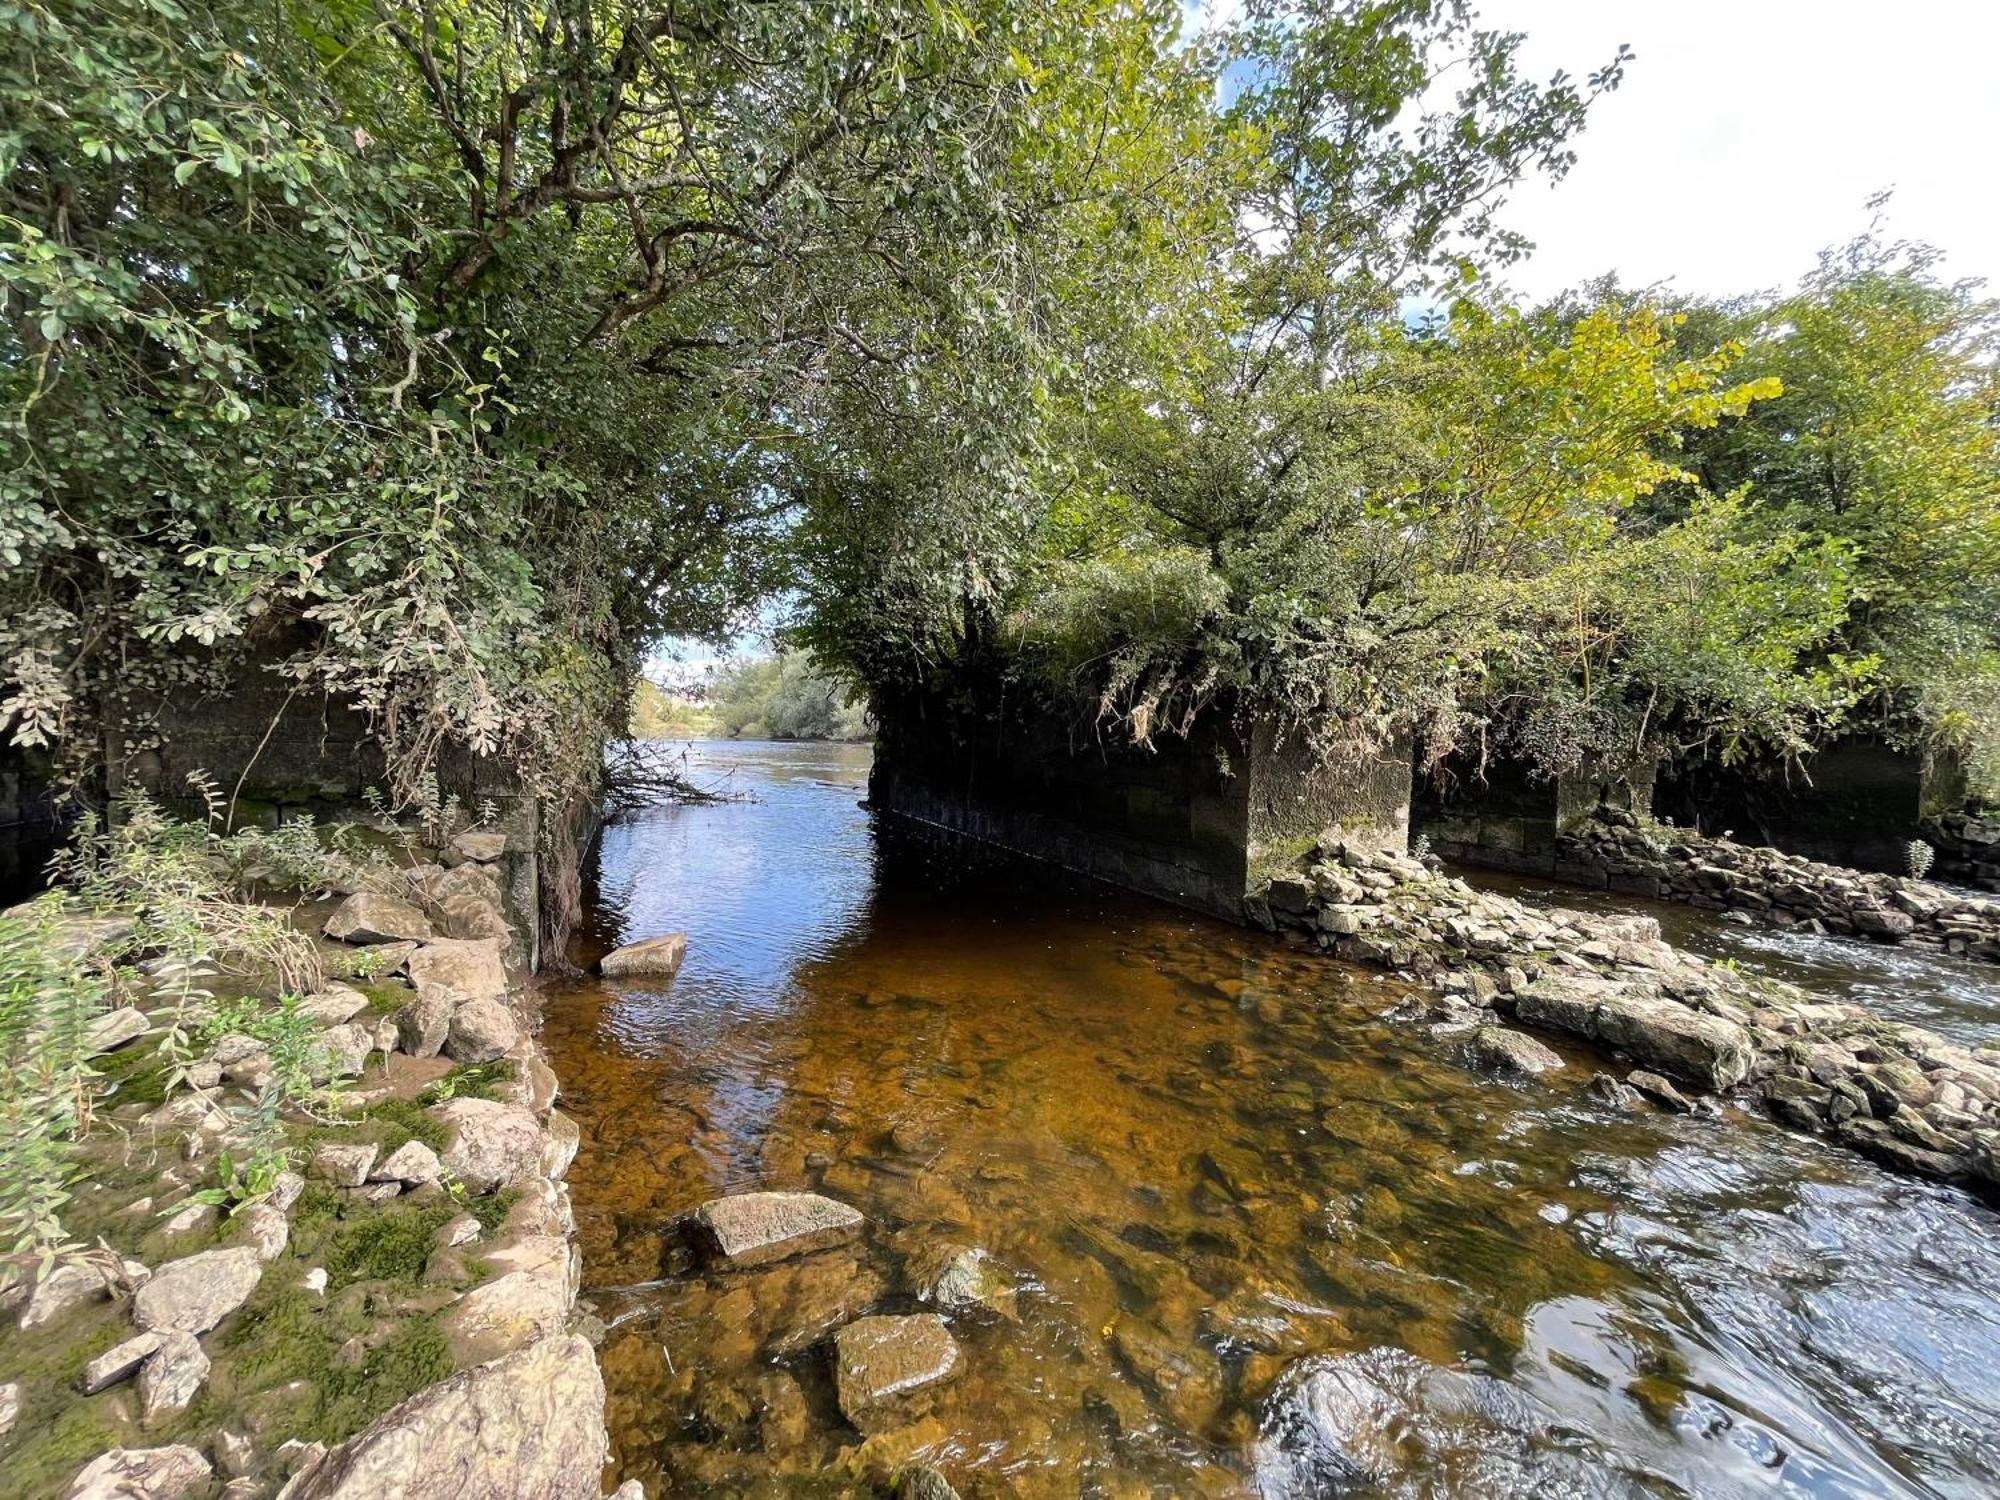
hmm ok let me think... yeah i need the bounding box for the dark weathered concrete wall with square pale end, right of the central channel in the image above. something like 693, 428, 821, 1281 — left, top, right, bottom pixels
870, 688, 1410, 922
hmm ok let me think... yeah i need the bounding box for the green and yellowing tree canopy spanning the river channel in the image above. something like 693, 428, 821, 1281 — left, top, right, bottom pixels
0, 0, 2000, 824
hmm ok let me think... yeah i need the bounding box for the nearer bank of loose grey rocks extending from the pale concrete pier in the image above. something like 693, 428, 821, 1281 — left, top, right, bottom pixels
1264, 832, 2000, 1194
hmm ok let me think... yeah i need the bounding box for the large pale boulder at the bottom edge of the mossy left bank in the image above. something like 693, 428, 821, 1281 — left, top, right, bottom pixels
286, 1334, 610, 1500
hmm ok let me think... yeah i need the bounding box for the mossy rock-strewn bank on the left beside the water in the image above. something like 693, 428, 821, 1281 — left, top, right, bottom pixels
0, 832, 624, 1500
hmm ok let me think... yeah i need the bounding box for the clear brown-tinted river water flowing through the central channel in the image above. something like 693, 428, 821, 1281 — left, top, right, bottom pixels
548, 744, 2000, 1500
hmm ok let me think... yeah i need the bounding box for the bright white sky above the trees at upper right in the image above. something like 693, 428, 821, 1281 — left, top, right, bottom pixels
1480, 0, 2000, 298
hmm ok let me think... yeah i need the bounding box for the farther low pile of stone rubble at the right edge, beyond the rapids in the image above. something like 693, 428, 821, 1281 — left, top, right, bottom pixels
1556, 808, 2000, 962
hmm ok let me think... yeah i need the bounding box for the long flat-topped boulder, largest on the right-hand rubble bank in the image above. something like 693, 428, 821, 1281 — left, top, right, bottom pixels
1514, 974, 1754, 1092
